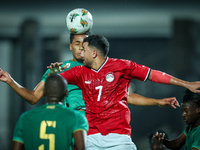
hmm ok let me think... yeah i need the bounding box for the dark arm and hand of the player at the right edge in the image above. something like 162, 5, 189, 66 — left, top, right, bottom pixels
154, 132, 186, 149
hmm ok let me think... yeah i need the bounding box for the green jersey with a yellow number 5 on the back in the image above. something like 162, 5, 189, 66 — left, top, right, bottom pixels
13, 104, 88, 150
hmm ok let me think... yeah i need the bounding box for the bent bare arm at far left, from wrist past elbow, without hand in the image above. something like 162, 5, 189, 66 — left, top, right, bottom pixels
7, 78, 44, 104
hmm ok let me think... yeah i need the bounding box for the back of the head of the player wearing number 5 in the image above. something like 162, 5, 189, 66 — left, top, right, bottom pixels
45, 74, 68, 100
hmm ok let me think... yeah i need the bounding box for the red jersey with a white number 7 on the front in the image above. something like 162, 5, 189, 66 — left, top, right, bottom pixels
60, 58, 150, 135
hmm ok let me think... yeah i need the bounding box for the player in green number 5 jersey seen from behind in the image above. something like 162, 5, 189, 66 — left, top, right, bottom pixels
13, 75, 88, 150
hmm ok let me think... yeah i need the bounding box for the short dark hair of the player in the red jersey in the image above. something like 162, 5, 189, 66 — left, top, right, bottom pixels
83, 34, 110, 56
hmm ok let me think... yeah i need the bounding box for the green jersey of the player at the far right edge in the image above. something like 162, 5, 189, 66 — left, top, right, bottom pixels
184, 125, 200, 150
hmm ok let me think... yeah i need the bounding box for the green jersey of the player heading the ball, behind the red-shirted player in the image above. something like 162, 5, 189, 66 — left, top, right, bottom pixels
42, 60, 85, 110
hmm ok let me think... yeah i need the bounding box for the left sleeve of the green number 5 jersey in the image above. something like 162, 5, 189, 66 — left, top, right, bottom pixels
12, 114, 24, 143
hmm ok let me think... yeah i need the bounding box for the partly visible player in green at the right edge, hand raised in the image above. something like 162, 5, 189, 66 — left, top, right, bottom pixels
154, 90, 200, 150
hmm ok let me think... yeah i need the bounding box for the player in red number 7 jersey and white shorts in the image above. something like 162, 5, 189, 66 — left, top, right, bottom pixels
48, 35, 200, 150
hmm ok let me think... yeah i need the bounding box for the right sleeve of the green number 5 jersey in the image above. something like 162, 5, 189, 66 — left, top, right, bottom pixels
73, 111, 89, 132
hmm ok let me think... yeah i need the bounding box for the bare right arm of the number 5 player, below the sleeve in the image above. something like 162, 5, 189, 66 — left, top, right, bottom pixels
73, 130, 87, 150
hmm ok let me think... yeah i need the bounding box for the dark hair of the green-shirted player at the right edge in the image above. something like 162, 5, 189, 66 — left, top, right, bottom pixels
183, 89, 200, 107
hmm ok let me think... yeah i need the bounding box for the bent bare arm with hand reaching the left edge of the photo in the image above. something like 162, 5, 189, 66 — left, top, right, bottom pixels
0, 69, 44, 104
